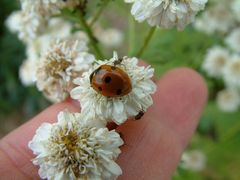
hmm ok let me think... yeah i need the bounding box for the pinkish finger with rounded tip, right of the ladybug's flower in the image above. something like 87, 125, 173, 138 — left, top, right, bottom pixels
118, 68, 207, 180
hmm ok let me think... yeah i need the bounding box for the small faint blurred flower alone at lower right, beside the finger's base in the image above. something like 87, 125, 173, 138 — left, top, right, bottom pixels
181, 150, 206, 171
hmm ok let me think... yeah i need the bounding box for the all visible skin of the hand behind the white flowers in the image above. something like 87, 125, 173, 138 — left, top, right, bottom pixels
0, 68, 207, 180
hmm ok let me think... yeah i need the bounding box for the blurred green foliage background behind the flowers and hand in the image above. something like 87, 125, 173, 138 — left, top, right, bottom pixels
0, 0, 240, 180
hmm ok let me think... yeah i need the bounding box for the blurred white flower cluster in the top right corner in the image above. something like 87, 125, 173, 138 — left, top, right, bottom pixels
195, 0, 240, 34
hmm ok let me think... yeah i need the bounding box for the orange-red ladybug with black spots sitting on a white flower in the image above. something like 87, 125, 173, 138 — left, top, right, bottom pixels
90, 60, 132, 97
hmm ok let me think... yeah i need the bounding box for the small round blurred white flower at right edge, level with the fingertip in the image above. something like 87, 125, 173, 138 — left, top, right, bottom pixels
217, 89, 240, 112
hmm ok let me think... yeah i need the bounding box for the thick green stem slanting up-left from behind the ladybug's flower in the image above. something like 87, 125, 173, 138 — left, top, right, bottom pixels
75, 11, 104, 59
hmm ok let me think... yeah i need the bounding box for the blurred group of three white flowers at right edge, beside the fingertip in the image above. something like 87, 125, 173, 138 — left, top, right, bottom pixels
202, 46, 240, 112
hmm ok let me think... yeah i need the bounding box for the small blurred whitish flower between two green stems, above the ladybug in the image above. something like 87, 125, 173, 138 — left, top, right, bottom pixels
96, 28, 123, 47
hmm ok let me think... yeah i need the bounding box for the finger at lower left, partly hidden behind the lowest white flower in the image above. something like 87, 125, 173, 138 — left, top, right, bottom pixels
0, 100, 79, 180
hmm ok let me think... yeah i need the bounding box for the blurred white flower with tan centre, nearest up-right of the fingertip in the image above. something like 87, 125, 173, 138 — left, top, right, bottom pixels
202, 46, 230, 78
